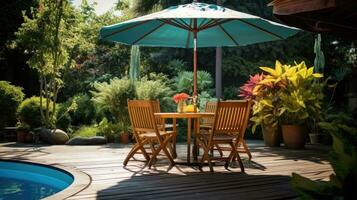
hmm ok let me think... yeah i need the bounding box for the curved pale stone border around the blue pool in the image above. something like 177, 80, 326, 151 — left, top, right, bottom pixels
0, 159, 92, 200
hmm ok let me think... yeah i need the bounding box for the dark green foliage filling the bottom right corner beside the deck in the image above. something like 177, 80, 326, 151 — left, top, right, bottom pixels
291, 123, 357, 199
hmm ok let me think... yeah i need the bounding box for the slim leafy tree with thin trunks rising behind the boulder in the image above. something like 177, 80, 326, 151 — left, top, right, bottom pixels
16, 0, 73, 127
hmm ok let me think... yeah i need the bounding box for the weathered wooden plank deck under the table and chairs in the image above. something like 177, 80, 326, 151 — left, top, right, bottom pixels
0, 141, 332, 200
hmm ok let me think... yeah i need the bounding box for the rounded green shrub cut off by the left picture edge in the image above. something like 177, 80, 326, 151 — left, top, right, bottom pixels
0, 81, 25, 128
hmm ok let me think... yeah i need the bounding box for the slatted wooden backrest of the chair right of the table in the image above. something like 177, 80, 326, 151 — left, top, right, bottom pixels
213, 100, 251, 138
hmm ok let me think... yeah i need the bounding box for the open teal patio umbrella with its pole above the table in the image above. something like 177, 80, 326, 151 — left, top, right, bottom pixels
100, 1, 299, 97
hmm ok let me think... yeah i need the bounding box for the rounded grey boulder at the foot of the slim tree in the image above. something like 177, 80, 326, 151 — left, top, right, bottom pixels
39, 128, 69, 144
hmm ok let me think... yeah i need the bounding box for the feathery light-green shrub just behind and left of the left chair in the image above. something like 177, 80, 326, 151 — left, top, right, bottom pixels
92, 78, 135, 123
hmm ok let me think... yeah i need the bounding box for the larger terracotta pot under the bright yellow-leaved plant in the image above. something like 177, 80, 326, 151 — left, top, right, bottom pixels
281, 125, 306, 149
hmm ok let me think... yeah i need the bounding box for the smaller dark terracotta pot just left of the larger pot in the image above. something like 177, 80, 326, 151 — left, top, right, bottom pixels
262, 125, 281, 147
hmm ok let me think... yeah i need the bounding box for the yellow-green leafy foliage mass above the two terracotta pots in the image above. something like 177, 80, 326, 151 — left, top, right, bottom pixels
251, 61, 323, 131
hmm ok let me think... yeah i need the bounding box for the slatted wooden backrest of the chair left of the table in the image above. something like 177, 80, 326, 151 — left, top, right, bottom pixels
128, 100, 157, 133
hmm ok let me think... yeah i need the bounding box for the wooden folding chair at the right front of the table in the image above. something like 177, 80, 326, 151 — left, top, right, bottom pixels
197, 101, 251, 172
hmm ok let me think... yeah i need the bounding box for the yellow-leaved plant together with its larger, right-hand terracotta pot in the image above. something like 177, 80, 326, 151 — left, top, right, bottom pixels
280, 62, 323, 148
